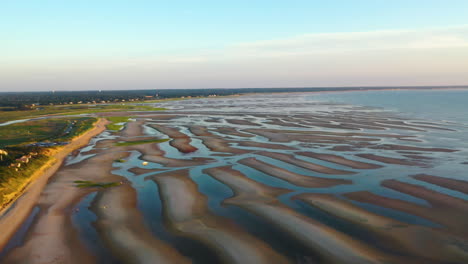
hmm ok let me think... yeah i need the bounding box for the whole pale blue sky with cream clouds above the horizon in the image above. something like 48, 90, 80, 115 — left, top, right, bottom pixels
0, 0, 468, 91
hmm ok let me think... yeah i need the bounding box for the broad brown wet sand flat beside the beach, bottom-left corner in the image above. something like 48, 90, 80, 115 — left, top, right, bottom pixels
0, 152, 127, 263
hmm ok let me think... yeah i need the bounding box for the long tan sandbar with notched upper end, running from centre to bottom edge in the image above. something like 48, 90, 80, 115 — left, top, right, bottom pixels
204, 166, 403, 263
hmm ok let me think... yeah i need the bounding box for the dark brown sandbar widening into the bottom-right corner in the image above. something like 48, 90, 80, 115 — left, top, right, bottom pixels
293, 194, 468, 263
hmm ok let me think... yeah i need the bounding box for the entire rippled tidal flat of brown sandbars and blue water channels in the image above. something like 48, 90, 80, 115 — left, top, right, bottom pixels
0, 93, 468, 264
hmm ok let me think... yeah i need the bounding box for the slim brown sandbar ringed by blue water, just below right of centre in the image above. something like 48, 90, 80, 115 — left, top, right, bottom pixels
238, 158, 352, 188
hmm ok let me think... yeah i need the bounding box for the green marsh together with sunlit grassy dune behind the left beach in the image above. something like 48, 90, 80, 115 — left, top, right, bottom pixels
0, 117, 97, 208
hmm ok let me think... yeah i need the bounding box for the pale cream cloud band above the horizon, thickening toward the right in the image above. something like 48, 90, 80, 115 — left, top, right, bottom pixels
0, 25, 468, 90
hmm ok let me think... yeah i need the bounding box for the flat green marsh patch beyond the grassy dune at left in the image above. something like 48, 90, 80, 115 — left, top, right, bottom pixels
0, 117, 97, 147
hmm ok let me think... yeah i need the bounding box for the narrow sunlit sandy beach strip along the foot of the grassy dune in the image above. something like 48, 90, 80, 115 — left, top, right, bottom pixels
0, 118, 109, 249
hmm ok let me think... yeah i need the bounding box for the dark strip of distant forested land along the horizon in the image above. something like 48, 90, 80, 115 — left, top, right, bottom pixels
0, 86, 468, 111
